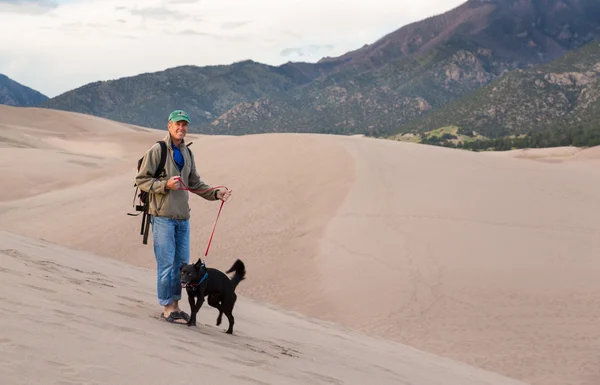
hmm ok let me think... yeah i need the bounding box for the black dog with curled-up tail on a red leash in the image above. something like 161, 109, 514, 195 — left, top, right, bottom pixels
180, 258, 246, 334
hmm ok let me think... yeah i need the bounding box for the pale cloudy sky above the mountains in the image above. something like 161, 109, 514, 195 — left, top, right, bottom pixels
0, 0, 465, 97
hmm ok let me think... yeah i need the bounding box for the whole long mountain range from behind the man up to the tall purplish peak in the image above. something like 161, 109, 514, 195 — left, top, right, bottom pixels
39, 0, 600, 136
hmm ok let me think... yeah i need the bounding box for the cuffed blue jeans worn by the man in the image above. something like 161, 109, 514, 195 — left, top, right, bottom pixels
151, 216, 190, 306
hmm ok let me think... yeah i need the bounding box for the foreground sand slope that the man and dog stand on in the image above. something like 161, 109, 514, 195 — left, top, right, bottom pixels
0, 232, 522, 385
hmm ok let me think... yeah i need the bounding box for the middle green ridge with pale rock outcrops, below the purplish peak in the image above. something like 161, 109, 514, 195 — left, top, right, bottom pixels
202, 46, 501, 135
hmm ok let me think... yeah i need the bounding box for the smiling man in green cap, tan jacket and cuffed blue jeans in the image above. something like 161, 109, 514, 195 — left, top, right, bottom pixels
136, 110, 231, 324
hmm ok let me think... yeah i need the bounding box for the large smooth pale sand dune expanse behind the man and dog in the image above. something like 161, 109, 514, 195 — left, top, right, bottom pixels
0, 107, 600, 385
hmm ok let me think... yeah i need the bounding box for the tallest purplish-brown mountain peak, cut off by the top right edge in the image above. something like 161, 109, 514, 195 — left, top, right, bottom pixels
319, 0, 600, 69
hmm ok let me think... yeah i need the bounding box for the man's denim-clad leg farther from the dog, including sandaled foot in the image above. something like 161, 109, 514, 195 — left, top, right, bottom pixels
152, 216, 184, 323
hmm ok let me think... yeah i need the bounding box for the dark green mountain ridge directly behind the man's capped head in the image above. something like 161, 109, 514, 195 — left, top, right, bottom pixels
42, 60, 336, 128
